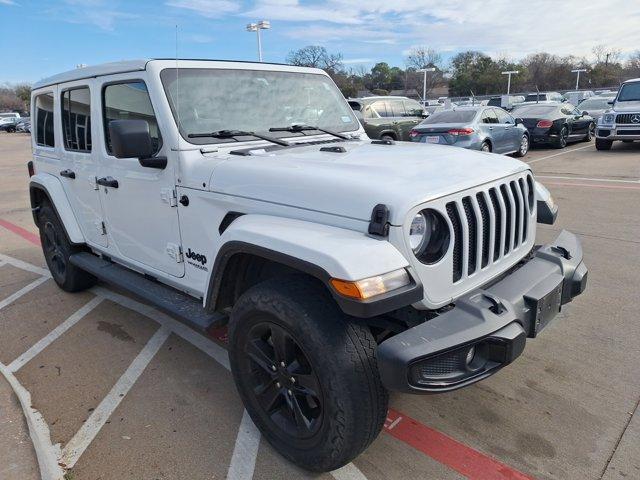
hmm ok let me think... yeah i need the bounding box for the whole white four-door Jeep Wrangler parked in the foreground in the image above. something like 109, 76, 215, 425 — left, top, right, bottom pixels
29, 60, 587, 471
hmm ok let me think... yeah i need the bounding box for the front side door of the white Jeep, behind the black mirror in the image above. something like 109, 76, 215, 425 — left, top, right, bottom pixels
98, 78, 184, 277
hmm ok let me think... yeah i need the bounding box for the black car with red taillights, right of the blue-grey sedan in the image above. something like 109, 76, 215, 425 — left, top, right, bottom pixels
511, 102, 596, 148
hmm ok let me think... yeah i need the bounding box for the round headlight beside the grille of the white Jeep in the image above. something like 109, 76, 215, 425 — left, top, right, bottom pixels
409, 209, 450, 265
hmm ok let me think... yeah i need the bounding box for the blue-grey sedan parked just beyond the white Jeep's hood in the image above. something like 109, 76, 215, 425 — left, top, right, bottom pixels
411, 106, 529, 157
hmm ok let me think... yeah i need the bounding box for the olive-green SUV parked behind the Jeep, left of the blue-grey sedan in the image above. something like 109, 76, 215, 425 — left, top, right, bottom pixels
348, 97, 429, 141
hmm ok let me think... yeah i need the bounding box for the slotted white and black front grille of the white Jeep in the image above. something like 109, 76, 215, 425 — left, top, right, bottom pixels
446, 175, 533, 283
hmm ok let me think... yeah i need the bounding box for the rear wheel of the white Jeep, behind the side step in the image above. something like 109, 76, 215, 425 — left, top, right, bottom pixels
38, 202, 96, 292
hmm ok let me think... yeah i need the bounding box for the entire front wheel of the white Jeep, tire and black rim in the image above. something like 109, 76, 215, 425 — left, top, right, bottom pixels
229, 275, 388, 472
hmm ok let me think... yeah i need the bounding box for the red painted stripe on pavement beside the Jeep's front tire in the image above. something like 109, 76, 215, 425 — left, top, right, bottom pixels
385, 408, 533, 480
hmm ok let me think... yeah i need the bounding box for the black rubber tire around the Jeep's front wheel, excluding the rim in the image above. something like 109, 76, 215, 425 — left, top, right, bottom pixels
229, 275, 388, 472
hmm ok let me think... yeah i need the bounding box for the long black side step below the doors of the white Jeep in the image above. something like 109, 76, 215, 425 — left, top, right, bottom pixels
69, 252, 227, 333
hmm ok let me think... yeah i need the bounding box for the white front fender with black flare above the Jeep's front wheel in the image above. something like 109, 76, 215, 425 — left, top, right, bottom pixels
204, 215, 423, 318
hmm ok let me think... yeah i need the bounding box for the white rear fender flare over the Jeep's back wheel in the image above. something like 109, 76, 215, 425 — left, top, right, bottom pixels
29, 173, 85, 245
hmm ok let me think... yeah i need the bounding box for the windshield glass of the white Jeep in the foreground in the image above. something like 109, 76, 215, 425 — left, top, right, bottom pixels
160, 68, 359, 144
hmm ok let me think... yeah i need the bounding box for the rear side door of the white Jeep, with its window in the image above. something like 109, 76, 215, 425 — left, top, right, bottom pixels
57, 81, 107, 247
